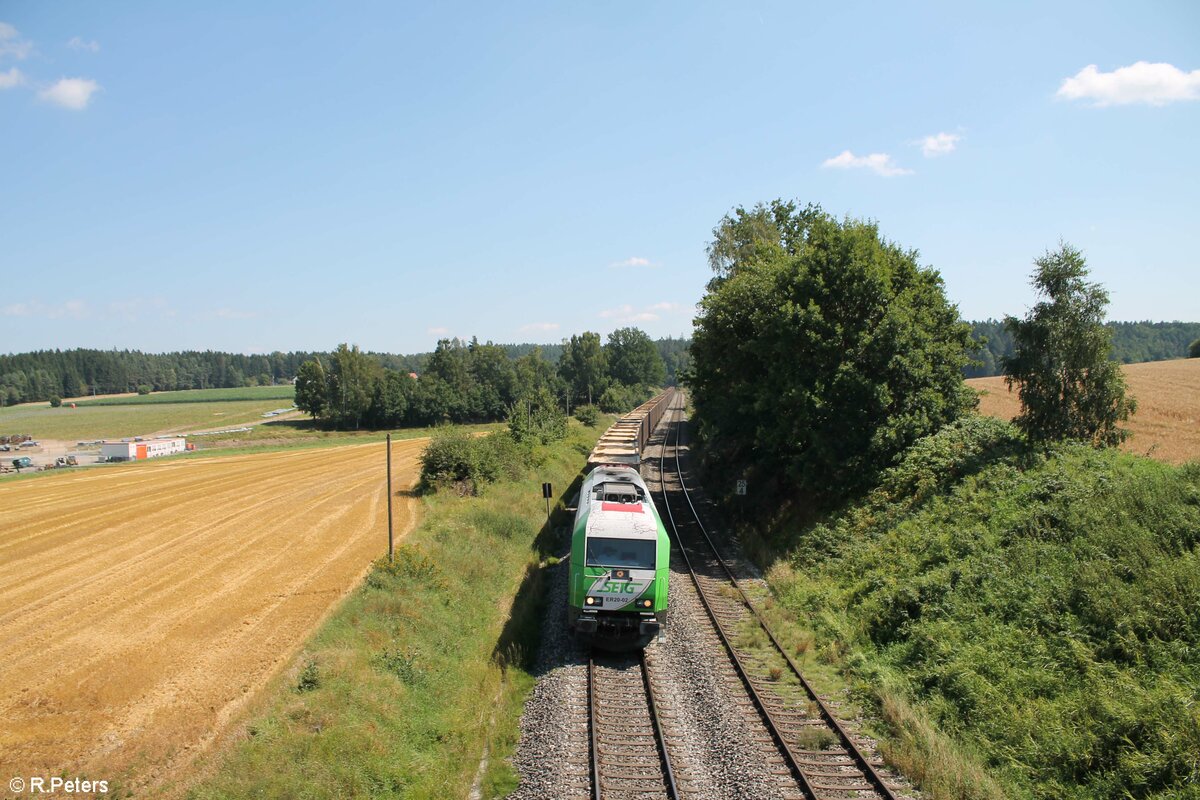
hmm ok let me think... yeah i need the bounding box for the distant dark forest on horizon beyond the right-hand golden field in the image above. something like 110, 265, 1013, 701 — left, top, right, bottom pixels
964, 319, 1200, 378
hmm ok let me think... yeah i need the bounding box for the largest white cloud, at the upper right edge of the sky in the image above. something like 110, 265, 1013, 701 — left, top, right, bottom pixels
1057, 61, 1200, 106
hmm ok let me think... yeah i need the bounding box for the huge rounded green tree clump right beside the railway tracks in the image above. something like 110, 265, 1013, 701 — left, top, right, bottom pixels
689, 201, 973, 504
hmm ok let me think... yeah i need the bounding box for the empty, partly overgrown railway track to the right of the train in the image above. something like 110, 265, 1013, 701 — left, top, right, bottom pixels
659, 395, 898, 800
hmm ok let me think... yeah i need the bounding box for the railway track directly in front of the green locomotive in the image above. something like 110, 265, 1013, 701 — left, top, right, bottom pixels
588, 652, 679, 800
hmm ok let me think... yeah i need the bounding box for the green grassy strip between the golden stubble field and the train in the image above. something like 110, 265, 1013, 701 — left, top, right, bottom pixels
188, 425, 600, 800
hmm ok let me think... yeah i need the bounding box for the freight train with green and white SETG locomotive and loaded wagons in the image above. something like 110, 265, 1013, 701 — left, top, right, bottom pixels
566, 391, 673, 650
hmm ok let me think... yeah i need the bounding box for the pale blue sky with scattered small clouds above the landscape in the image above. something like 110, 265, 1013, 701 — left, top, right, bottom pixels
0, 0, 1200, 353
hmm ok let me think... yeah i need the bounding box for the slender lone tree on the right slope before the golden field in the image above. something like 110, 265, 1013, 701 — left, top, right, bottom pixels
1003, 243, 1138, 446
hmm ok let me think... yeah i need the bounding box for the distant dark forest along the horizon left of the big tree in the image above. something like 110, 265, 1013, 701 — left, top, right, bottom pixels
0, 337, 690, 405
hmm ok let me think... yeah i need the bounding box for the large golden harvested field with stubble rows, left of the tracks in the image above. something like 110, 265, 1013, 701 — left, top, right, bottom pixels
0, 440, 425, 788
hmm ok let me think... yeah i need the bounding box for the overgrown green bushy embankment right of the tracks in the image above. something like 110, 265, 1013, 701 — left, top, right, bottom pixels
753, 417, 1200, 800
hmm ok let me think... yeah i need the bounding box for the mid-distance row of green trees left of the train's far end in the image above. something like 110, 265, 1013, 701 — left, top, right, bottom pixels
296, 327, 666, 434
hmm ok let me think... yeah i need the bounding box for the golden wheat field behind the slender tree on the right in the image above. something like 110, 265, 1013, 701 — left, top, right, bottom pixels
967, 359, 1200, 464
